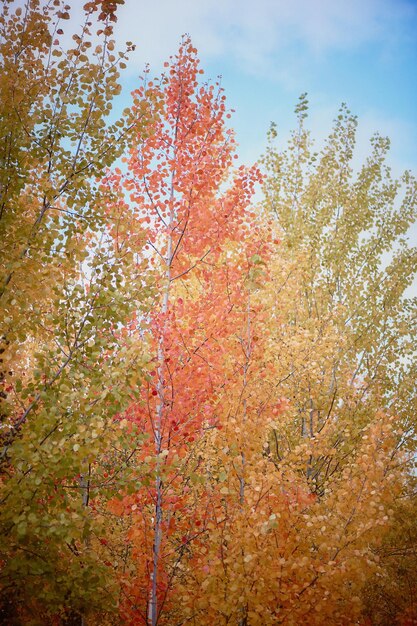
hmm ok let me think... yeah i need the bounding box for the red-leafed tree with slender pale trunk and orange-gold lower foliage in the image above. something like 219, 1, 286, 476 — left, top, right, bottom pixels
97, 47, 410, 625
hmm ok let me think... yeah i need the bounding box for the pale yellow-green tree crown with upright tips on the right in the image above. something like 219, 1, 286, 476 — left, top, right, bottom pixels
256, 96, 417, 623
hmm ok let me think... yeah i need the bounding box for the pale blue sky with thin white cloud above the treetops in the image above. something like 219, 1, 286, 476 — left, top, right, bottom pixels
107, 0, 417, 178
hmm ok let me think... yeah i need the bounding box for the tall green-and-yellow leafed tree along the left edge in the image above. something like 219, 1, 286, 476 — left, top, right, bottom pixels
0, 0, 148, 623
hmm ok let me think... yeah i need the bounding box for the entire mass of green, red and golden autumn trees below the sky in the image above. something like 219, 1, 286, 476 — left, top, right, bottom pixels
0, 0, 417, 626
